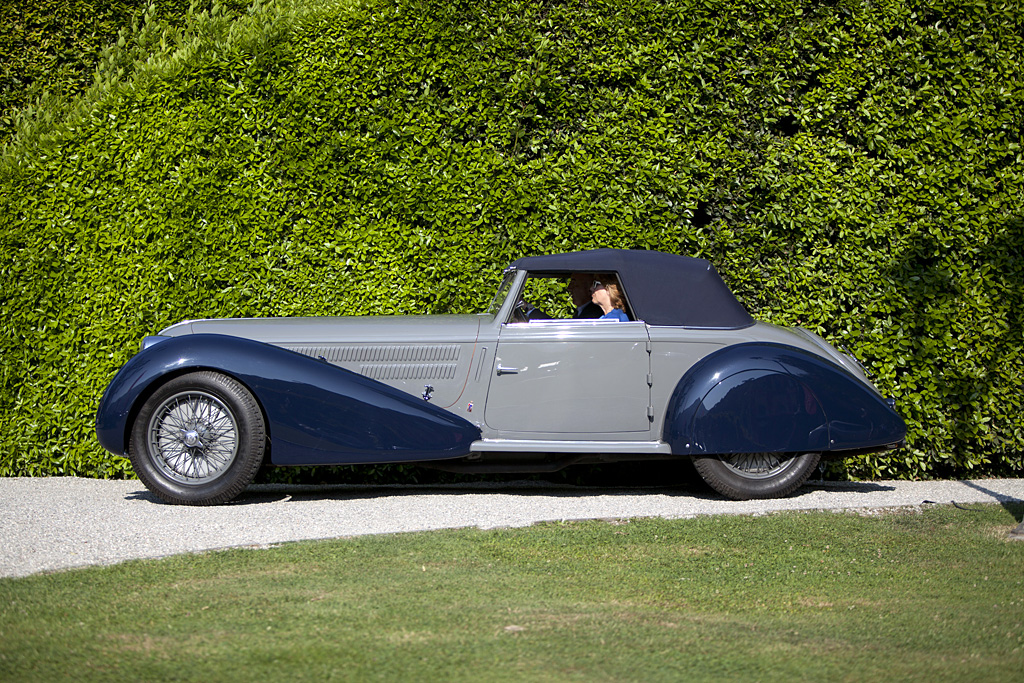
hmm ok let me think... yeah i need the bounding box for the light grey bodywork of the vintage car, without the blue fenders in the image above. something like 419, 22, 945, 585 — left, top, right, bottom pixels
160, 271, 874, 455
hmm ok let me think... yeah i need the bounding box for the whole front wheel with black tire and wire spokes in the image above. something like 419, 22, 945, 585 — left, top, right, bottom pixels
128, 372, 266, 505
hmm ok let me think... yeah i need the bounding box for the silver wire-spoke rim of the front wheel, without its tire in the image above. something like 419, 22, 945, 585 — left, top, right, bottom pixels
148, 391, 239, 484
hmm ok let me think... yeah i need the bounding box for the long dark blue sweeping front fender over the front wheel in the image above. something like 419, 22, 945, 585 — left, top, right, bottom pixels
96, 334, 480, 465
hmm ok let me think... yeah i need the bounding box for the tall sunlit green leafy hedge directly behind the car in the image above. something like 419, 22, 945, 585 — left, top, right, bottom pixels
0, 0, 1024, 477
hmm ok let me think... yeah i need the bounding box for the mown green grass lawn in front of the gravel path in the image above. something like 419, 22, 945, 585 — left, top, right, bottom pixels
0, 505, 1024, 682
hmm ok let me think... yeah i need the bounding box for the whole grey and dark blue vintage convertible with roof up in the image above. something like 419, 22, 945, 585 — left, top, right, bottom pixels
96, 249, 905, 505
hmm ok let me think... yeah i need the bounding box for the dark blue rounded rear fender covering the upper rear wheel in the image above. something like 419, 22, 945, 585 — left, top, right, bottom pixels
664, 342, 906, 455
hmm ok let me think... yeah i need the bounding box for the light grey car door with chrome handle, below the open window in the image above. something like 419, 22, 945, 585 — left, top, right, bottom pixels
484, 319, 650, 439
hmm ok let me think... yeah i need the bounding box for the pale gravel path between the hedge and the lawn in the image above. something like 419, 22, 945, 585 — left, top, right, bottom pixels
0, 477, 1024, 577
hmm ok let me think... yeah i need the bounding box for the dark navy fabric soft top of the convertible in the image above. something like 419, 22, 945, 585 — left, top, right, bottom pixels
512, 249, 754, 330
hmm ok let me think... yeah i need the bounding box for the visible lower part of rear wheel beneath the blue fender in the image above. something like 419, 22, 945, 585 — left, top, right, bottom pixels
693, 453, 821, 501
